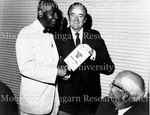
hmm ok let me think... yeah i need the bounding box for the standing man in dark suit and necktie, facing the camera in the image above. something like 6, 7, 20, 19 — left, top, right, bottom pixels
55, 2, 115, 115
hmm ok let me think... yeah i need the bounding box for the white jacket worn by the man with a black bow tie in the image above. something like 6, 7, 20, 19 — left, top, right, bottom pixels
16, 20, 59, 114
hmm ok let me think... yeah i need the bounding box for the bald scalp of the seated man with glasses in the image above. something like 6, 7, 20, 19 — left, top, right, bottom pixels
115, 70, 145, 99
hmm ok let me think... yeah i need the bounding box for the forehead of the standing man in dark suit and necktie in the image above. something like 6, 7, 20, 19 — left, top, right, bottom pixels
70, 5, 85, 14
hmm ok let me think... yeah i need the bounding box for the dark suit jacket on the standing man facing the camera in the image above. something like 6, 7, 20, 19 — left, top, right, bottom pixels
55, 28, 115, 115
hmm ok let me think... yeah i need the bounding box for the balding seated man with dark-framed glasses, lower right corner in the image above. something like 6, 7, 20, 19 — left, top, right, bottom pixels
96, 71, 148, 115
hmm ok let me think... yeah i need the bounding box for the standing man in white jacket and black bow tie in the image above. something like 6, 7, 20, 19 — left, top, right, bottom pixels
16, 0, 66, 115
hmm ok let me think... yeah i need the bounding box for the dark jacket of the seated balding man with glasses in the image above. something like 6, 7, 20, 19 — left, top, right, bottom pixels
96, 98, 149, 115
